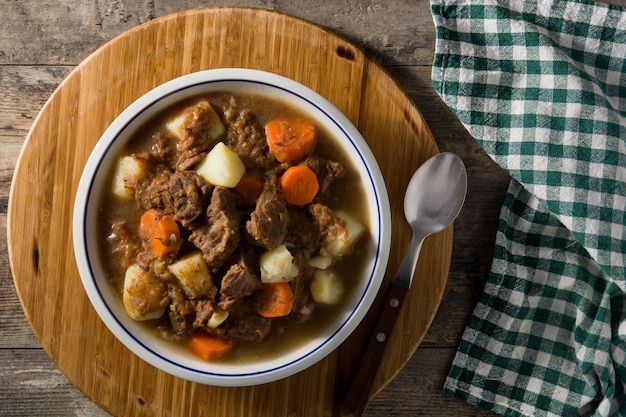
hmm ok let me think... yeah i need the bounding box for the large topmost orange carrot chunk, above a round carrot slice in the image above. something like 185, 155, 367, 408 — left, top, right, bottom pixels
265, 117, 316, 163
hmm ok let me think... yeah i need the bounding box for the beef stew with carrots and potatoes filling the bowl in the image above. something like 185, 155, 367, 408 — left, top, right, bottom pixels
98, 93, 368, 361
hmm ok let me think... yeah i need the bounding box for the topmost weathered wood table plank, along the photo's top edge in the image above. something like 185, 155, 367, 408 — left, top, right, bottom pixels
0, 0, 434, 65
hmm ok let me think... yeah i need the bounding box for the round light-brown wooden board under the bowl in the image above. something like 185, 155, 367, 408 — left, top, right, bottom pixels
8, 8, 452, 417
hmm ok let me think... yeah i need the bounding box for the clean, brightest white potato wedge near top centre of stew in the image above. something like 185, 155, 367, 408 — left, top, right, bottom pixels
195, 142, 246, 188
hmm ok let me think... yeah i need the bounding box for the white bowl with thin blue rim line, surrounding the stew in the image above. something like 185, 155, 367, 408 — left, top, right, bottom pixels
73, 69, 391, 386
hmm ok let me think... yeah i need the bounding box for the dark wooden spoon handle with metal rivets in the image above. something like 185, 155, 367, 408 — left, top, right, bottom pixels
342, 283, 409, 417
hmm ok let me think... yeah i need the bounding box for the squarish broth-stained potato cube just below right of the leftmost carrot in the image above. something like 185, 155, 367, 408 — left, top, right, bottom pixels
167, 251, 215, 298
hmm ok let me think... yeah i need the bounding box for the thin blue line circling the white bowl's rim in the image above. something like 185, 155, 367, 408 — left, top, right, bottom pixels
82, 76, 386, 378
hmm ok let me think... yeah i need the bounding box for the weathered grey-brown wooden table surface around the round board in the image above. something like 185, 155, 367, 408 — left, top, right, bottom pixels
0, 0, 509, 416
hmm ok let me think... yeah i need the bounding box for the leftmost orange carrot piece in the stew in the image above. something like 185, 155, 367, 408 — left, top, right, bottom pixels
139, 209, 182, 258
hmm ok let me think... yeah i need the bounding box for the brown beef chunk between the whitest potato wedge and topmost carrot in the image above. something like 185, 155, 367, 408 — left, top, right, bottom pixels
225, 110, 276, 170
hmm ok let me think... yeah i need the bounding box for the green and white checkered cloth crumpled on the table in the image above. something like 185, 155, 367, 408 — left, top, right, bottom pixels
431, 0, 626, 416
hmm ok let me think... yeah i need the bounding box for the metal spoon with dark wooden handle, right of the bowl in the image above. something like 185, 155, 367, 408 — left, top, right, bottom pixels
342, 152, 467, 417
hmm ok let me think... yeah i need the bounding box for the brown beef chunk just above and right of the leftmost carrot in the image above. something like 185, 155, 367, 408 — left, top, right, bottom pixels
169, 171, 212, 227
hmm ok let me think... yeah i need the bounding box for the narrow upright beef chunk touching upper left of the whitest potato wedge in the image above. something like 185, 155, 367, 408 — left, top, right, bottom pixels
176, 106, 216, 171
